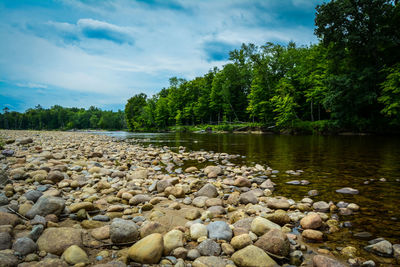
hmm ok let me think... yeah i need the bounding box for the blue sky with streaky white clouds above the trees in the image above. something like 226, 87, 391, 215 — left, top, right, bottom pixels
0, 0, 322, 112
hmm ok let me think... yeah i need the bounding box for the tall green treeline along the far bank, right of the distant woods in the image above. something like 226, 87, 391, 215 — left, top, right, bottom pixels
125, 0, 400, 132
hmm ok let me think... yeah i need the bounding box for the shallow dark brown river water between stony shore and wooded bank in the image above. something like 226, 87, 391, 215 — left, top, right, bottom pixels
93, 132, 400, 262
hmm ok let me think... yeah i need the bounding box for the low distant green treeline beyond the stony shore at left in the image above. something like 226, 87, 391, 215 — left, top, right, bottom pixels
0, 105, 126, 130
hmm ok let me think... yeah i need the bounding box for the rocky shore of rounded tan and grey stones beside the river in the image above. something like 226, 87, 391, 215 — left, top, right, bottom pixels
0, 131, 400, 267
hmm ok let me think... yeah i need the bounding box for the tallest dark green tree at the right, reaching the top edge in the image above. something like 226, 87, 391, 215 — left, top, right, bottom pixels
315, 0, 400, 130
